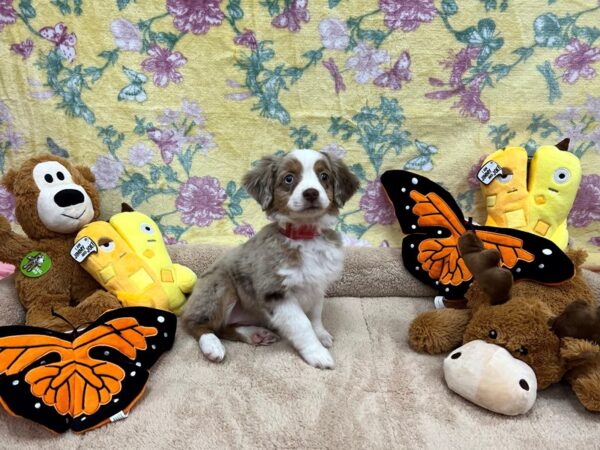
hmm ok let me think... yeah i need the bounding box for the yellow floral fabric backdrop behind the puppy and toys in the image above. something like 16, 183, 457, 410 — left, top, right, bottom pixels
0, 0, 600, 264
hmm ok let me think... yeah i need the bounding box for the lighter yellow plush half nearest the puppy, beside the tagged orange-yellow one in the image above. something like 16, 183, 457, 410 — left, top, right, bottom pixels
110, 204, 197, 313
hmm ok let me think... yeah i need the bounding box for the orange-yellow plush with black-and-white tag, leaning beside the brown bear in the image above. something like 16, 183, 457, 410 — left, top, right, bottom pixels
71, 221, 169, 310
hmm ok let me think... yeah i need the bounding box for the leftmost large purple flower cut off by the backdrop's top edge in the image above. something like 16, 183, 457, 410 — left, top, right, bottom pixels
167, 0, 225, 34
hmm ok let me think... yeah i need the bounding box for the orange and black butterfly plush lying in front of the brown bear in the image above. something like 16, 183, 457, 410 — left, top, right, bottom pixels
0, 307, 177, 433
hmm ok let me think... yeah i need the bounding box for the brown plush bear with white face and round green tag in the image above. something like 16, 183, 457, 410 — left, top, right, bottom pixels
0, 156, 121, 331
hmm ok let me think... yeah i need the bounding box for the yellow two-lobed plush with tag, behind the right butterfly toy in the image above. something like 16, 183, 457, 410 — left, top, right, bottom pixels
478, 139, 581, 250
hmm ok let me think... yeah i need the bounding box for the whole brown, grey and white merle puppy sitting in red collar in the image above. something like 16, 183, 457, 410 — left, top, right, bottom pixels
183, 150, 358, 369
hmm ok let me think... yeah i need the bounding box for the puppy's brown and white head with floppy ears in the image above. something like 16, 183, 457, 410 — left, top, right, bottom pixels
243, 150, 358, 221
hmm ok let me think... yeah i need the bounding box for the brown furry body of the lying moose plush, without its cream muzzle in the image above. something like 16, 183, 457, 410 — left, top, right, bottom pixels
409, 232, 600, 411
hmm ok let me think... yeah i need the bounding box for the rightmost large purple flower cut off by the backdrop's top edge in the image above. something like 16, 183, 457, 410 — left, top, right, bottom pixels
379, 0, 437, 31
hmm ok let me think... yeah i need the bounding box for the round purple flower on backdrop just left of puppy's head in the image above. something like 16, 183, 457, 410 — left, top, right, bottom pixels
175, 176, 227, 227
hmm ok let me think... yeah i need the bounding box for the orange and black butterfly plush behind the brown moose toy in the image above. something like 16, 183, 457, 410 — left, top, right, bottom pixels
381, 170, 575, 299
